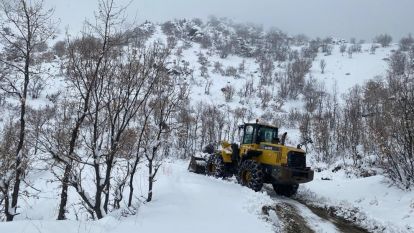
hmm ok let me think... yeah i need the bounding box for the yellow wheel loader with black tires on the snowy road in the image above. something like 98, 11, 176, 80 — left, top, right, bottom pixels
189, 122, 314, 196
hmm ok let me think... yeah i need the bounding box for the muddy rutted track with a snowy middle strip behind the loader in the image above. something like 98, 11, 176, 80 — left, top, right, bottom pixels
262, 187, 368, 233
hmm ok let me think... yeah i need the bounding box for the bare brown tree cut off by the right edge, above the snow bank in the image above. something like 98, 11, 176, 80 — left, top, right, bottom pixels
374, 50, 414, 189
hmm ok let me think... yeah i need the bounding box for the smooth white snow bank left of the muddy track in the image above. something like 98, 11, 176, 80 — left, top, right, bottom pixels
0, 161, 273, 233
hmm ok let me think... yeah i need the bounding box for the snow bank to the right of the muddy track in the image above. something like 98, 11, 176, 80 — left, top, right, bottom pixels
297, 169, 414, 232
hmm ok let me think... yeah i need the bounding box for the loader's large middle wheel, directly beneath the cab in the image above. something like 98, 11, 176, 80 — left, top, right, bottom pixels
237, 160, 263, 192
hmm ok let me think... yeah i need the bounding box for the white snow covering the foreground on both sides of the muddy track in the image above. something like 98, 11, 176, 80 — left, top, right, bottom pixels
4, 160, 414, 233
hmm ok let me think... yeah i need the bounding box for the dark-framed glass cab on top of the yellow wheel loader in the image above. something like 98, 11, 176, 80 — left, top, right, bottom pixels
239, 123, 280, 145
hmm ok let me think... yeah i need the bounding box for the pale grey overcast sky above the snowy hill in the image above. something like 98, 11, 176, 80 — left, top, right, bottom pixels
46, 0, 414, 41
